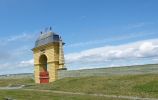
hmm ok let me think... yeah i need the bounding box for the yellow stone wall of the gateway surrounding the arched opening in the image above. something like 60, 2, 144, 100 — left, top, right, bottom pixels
33, 43, 64, 83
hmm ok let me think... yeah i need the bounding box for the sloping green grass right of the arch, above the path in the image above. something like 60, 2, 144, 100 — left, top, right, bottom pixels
27, 74, 158, 98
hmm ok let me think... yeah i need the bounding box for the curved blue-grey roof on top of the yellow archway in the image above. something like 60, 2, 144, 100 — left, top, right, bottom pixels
35, 31, 61, 48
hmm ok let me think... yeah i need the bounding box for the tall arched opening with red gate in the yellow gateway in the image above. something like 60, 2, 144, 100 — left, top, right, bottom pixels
39, 55, 49, 83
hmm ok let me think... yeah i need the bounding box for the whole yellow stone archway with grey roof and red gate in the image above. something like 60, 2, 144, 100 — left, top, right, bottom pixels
32, 31, 64, 83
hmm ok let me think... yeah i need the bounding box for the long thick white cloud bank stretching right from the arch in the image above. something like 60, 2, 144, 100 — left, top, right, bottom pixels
65, 39, 158, 64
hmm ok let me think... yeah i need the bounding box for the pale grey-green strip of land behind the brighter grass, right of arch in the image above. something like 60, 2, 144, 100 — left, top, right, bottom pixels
59, 64, 158, 78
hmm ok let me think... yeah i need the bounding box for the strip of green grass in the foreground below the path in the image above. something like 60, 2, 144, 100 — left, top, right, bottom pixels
0, 90, 127, 100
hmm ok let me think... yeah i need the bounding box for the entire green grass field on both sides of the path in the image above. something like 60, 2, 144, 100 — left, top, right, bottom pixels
0, 66, 158, 100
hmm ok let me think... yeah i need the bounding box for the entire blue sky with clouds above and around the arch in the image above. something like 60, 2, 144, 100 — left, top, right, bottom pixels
0, 0, 158, 74
